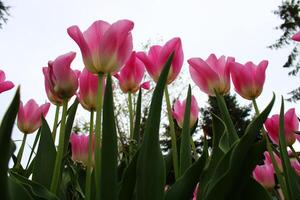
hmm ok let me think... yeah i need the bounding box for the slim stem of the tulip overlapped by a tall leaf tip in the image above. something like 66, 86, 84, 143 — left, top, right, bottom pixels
165, 86, 179, 180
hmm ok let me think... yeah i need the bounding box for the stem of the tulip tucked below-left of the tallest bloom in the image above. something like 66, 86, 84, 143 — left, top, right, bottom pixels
85, 110, 94, 200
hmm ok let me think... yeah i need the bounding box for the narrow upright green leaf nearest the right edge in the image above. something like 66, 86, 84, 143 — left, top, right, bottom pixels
279, 97, 300, 200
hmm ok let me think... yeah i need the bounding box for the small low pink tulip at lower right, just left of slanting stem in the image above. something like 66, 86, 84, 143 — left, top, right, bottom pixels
252, 164, 275, 189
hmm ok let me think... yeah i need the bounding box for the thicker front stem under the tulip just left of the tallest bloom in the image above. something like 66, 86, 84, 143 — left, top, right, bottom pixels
50, 99, 68, 194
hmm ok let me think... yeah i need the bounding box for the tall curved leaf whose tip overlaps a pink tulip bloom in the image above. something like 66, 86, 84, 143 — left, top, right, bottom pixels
136, 53, 174, 200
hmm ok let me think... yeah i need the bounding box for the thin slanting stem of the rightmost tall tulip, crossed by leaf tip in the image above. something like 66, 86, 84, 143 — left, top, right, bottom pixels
252, 99, 287, 197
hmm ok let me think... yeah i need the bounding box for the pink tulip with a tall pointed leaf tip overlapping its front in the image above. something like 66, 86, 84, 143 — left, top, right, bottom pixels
137, 38, 183, 84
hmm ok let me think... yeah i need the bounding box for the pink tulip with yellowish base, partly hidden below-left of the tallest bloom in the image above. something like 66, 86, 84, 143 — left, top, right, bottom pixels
77, 68, 105, 111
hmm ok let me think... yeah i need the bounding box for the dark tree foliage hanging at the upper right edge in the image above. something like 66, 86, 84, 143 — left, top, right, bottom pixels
269, 0, 300, 102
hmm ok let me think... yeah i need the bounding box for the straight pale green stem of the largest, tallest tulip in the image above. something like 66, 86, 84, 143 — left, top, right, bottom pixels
95, 72, 104, 199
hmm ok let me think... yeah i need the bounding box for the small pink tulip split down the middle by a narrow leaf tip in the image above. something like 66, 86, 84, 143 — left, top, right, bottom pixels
173, 96, 199, 128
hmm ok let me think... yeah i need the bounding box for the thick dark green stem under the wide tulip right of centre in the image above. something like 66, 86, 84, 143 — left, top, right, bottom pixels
215, 92, 239, 152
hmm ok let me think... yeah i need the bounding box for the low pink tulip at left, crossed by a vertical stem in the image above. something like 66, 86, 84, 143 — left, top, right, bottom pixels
70, 133, 95, 166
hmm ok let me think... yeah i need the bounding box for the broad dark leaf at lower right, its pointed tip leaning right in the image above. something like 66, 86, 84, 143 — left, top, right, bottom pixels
204, 96, 275, 200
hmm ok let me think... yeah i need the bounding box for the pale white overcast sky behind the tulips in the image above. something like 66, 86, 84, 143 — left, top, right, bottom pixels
0, 0, 300, 159
